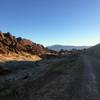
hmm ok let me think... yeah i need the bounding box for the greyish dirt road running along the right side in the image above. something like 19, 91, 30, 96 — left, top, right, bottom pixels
80, 56, 100, 100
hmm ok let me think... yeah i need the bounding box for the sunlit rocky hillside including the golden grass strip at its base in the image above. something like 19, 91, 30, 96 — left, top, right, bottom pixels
0, 32, 48, 61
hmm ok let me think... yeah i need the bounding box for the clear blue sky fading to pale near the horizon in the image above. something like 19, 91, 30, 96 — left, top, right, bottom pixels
0, 0, 100, 46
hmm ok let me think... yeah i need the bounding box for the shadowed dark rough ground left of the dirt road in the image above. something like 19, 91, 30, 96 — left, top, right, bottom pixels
0, 57, 82, 100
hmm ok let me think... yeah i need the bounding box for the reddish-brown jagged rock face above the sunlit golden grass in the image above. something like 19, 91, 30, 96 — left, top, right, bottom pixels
0, 32, 48, 55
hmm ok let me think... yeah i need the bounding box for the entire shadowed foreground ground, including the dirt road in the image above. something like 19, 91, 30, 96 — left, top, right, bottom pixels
0, 55, 100, 100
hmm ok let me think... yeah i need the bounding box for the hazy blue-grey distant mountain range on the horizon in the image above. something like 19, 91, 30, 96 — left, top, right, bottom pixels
48, 45, 89, 51
